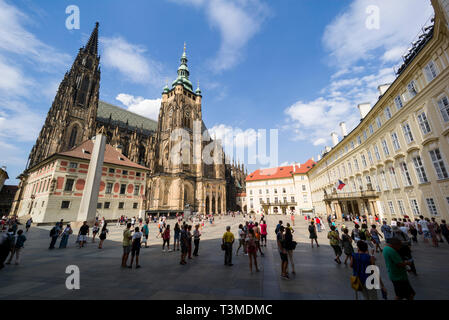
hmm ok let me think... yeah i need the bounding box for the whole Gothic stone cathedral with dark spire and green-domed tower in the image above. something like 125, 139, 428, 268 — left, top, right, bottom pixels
11, 23, 245, 215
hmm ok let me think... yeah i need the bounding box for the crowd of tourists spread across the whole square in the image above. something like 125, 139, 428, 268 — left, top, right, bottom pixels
0, 212, 449, 300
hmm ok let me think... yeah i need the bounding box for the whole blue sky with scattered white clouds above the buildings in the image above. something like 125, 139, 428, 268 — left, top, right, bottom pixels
0, 0, 433, 183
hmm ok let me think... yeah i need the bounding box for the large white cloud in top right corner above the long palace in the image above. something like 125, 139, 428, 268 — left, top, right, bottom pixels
323, 0, 433, 68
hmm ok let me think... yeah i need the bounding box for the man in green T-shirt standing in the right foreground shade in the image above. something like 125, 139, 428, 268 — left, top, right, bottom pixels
383, 237, 416, 300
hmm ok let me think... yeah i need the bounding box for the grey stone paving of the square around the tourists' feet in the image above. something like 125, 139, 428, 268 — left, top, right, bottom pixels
0, 216, 449, 300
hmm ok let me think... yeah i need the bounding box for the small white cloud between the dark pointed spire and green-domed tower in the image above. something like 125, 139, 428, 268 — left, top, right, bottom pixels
100, 37, 163, 86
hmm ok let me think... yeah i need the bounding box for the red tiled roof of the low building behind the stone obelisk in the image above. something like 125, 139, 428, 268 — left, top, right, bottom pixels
58, 140, 149, 170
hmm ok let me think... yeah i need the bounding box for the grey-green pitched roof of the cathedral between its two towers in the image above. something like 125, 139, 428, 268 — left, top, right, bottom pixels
97, 101, 157, 134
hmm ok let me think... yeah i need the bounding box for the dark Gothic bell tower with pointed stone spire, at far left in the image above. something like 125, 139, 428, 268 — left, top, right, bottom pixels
27, 22, 100, 168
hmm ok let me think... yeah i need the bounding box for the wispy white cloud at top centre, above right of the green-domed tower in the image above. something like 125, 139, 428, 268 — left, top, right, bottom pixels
171, 0, 269, 72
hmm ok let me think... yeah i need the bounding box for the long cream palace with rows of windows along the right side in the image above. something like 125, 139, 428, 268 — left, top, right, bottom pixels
308, 0, 449, 220
